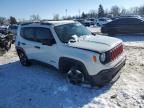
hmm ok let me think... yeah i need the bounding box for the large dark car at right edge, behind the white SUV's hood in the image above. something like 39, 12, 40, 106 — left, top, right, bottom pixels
101, 17, 144, 35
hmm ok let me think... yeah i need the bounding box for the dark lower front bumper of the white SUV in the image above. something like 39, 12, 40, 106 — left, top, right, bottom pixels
90, 57, 126, 86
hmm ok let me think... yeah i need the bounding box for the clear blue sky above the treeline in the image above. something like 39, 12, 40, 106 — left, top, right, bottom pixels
0, 0, 144, 19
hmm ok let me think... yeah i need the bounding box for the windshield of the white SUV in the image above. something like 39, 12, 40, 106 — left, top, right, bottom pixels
54, 23, 91, 43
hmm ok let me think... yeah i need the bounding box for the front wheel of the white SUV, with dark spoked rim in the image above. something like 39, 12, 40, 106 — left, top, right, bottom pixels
67, 67, 85, 85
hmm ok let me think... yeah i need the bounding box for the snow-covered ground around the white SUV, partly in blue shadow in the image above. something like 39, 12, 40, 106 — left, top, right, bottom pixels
0, 36, 144, 108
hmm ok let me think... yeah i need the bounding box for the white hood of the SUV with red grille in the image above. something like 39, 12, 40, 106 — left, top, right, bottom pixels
68, 35, 122, 53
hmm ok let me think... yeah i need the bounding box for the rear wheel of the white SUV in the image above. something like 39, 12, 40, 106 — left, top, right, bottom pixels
18, 51, 31, 66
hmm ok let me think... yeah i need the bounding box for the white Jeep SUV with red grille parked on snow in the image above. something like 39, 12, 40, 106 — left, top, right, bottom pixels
16, 21, 126, 86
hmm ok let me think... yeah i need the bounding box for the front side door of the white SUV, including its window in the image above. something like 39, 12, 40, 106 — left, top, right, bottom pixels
35, 27, 58, 67
